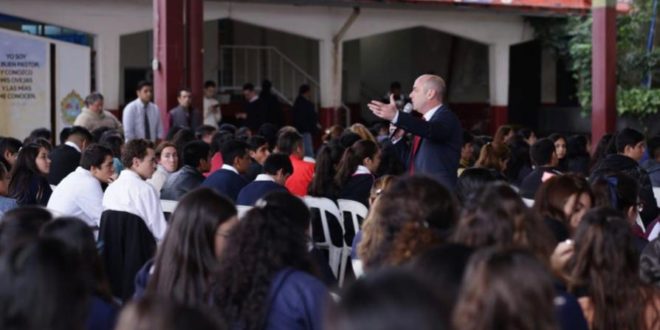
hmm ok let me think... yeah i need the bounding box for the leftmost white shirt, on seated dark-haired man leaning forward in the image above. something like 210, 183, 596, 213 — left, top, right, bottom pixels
47, 166, 103, 227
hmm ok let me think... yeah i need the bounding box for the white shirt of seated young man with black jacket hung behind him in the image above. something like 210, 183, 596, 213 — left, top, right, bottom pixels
103, 170, 167, 241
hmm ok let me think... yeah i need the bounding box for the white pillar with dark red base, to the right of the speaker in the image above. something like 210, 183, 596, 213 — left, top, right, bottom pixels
488, 43, 510, 133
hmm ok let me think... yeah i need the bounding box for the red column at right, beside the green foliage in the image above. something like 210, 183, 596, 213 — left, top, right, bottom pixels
591, 0, 616, 143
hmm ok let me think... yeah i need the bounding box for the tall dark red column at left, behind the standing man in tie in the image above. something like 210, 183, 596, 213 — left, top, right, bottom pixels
153, 0, 185, 132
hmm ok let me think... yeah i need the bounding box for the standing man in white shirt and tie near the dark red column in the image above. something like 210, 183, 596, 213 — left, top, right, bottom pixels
123, 81, 164, 142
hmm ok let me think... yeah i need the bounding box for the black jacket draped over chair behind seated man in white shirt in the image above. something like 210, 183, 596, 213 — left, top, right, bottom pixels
99, 210, 156, 301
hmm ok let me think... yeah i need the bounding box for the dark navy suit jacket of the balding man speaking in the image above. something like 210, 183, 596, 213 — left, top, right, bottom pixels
396, 105, 463, 189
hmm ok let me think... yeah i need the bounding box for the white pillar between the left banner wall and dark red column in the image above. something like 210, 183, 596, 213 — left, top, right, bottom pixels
94, 33, 121, 110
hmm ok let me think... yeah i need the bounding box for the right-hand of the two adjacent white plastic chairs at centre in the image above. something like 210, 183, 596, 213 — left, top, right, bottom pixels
337, 199, 369, 287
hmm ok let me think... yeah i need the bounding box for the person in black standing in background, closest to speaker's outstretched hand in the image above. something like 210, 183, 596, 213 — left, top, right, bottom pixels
292, 84, 319, 158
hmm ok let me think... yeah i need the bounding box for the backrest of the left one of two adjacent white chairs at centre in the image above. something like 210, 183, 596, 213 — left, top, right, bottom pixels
303, 196, 344, 248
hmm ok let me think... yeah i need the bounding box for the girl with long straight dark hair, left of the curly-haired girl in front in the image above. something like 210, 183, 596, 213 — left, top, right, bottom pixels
146, 188, 238, 306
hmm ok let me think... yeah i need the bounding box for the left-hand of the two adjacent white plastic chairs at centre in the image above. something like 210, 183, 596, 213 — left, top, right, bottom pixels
303, 196, 344, 278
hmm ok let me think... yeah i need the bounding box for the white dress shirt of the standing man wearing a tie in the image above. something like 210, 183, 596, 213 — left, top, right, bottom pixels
122, 98, 164, 142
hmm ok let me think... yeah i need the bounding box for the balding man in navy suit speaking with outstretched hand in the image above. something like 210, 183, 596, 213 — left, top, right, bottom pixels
369, 75, 463, 188
